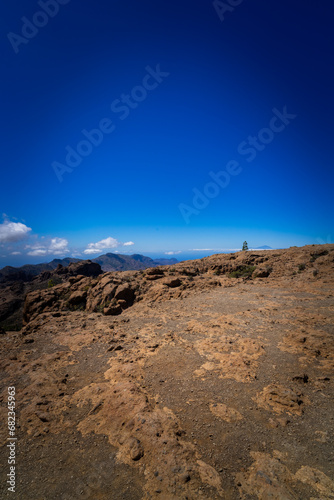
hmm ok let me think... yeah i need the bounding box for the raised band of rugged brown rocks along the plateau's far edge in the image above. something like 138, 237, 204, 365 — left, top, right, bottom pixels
13, 245, 334, 328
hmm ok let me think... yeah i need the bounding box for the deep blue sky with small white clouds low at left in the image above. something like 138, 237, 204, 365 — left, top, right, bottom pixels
0, 0, 334, 267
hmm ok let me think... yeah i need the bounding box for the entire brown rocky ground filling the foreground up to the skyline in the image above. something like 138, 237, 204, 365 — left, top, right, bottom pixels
0, 245, 334, 500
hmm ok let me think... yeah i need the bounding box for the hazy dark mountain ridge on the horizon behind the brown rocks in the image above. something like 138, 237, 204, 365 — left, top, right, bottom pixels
0, 253, 178, 282
